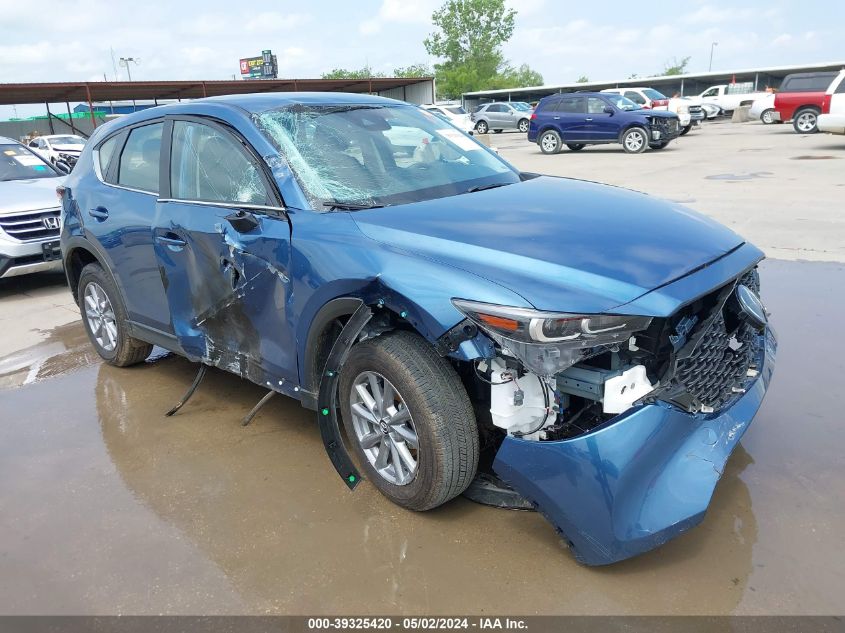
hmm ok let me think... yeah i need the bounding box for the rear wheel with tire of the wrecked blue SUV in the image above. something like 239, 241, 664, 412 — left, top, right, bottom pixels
78, 264, 153, 367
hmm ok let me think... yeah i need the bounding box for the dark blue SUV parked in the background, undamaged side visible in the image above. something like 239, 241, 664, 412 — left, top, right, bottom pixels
528, 92, 680, 154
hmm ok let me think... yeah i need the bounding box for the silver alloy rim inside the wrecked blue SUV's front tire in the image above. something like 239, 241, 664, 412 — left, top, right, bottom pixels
349, 371, 420, 486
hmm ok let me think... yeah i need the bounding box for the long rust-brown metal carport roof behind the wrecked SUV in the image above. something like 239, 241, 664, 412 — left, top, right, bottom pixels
0, 77, 432, 105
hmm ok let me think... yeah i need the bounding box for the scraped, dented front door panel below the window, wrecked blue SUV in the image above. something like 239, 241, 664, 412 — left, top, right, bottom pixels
153, 201, 297, 388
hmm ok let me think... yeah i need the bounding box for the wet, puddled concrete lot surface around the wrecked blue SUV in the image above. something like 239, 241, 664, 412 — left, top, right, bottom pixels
0, 118, 845, 614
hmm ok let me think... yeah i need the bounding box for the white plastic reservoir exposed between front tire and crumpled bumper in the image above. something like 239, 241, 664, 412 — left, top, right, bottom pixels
490, 358, 557, 440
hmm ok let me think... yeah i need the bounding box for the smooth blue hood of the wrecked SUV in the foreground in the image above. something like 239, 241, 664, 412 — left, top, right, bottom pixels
352, 176, 743, 313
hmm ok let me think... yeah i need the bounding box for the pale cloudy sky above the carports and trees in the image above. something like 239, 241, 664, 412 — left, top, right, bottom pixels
0, 0, 845, 118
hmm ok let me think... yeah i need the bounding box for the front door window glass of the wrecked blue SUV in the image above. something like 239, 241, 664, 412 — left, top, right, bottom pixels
170, 121, 270, 205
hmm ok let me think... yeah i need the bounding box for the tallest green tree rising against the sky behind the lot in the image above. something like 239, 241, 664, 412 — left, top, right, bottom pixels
423, 0, 516, 98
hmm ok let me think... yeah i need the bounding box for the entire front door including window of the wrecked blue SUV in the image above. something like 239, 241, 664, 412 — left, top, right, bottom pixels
153, 118, 297, 389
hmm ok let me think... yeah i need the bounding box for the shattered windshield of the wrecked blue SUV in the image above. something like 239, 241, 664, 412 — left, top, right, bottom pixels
255, 104, 519, 210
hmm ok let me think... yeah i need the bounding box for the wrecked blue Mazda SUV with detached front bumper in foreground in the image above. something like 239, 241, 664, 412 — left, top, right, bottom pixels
59, 93, 776, 565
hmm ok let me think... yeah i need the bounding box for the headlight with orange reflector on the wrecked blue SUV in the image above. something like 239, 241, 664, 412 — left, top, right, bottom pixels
452, 299, 651, 376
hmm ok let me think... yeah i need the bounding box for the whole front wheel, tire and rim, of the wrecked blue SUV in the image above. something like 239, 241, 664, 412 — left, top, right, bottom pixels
340, 331, 479, 510
